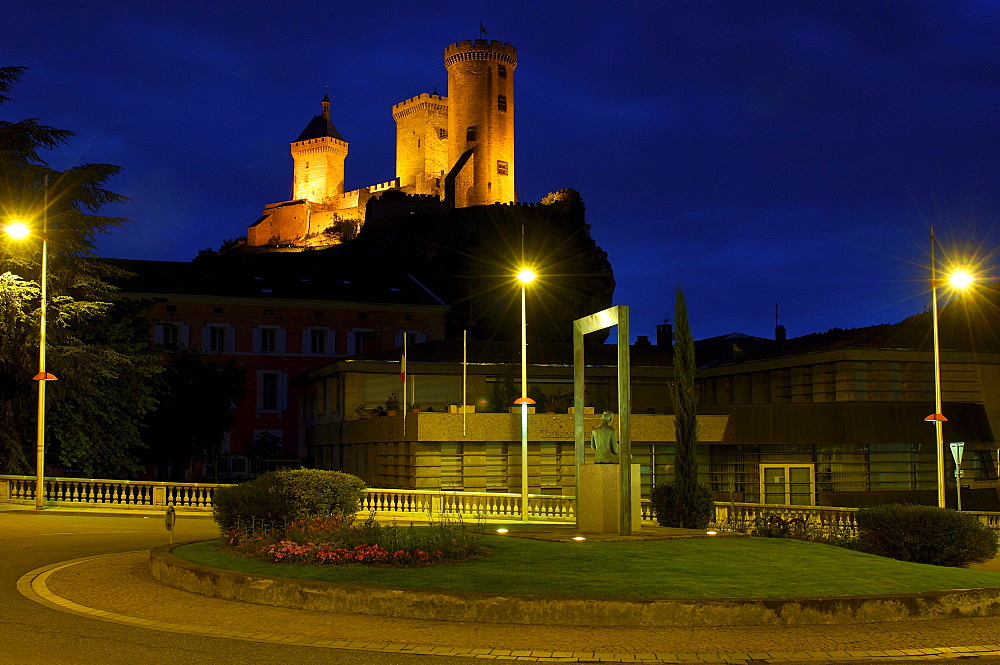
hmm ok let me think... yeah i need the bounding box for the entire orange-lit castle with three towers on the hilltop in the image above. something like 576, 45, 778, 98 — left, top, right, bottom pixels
247, 39, 517, 246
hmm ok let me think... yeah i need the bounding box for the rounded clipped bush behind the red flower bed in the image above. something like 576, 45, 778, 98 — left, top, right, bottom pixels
212, 469, 365, 531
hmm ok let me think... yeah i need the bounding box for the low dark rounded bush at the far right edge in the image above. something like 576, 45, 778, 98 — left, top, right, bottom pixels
857, 504, 997, 567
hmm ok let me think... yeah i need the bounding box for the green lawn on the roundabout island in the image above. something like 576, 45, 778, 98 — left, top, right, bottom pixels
173, 535, 1000, 598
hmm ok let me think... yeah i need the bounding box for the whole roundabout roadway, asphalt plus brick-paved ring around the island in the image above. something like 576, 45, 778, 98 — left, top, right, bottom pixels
7, 511, 1000, 665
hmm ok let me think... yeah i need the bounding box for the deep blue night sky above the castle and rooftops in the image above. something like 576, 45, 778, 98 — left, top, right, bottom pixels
0, 0, 1000, 338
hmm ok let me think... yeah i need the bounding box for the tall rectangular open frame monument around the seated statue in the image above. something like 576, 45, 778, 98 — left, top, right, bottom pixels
573, 305, 632, 536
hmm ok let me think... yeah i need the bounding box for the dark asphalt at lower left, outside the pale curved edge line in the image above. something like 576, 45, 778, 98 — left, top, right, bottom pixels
0, 512, 476, 665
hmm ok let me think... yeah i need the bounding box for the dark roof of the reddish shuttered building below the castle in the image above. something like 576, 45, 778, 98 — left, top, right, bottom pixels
106, 253, 445, 309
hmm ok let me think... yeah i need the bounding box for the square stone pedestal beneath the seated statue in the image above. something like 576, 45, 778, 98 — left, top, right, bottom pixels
576, 464, 642, 535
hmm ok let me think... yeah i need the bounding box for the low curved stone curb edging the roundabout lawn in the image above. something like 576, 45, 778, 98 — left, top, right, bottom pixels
149, 541, 1000, 627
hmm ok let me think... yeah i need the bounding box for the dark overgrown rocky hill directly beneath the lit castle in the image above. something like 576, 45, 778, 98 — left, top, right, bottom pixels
352, 190, 615, 342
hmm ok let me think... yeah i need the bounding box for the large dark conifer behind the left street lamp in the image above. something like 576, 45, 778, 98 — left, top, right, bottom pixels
0, 67, 158, 477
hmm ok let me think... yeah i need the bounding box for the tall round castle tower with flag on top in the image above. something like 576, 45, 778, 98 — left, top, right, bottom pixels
444, 39, 517, 208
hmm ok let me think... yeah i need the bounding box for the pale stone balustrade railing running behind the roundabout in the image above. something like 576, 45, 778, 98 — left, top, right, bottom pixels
0, 476, 1000, 536
